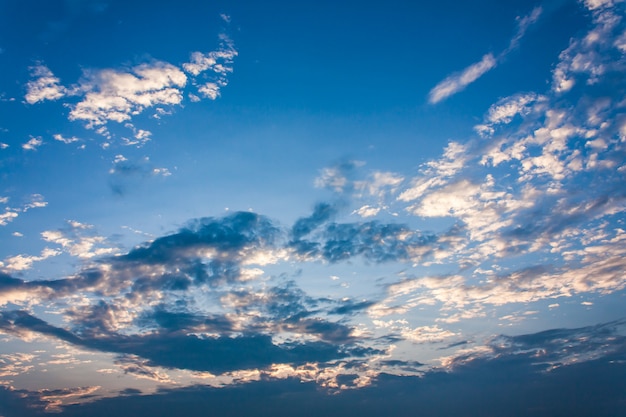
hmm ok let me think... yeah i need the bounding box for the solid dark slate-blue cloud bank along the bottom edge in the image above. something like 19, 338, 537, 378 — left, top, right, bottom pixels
0, 329, 626, 417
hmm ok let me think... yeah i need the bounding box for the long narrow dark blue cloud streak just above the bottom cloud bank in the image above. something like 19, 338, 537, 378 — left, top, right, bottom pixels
0, 311, 382, 373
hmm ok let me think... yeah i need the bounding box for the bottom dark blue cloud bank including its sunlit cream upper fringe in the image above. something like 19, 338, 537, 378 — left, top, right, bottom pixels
0, 323, 626, 417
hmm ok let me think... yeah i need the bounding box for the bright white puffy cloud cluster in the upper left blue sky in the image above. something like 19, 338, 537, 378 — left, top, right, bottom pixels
24, 28, 237, 141
